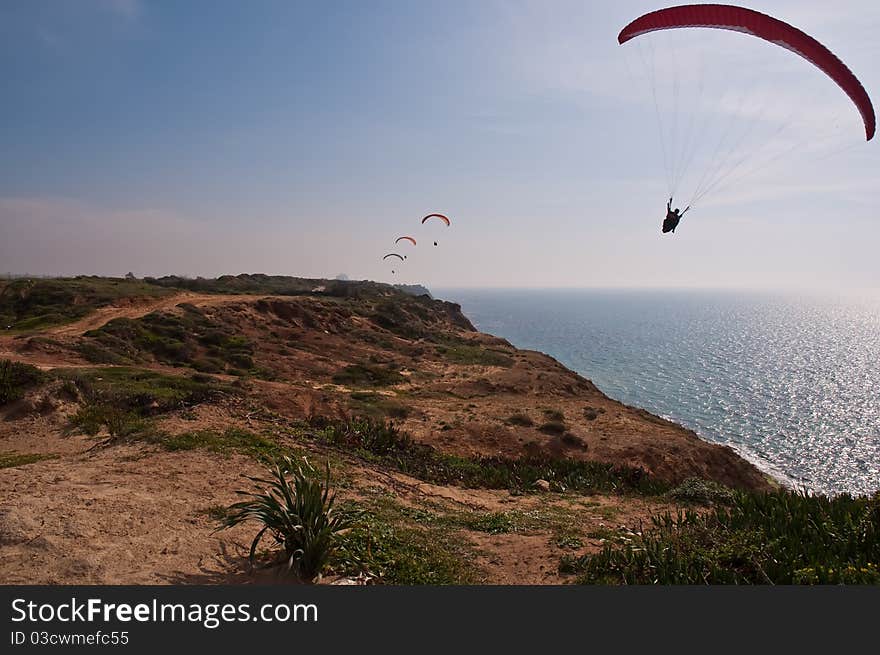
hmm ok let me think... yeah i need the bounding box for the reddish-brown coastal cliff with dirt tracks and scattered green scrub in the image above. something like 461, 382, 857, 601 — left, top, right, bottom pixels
0, 275, 771, 584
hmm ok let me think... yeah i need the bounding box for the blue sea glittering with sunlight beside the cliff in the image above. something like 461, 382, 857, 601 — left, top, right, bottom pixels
435, 289, 880, 494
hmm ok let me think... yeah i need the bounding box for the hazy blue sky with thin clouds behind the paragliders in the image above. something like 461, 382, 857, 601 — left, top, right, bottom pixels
0, 0, 880, 294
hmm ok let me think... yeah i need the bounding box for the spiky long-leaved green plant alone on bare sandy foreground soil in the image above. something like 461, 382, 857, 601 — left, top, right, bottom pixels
221, 457, 354, 582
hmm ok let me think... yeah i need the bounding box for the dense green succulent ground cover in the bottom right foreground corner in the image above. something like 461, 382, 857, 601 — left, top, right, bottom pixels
566, 491, 880, 584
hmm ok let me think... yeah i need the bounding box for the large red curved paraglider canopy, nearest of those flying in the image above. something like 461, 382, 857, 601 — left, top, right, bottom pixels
620, 4, 876, 140
